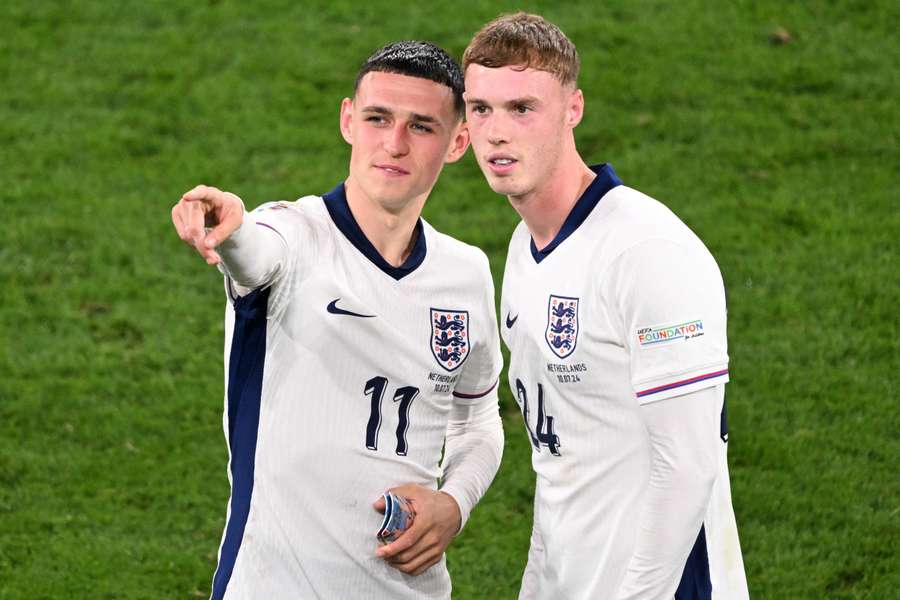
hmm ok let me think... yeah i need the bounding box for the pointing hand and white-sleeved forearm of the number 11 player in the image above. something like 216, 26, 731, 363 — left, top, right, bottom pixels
172, 185, 287, 289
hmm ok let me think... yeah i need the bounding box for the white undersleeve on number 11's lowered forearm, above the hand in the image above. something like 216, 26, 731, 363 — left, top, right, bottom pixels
441, 398, 503, 529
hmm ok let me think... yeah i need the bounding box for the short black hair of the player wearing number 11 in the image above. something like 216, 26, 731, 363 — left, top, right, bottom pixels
353, 40, 466, 116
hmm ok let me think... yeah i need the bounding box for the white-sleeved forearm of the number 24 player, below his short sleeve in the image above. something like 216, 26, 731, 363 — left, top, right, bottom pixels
615, 387, 721, 600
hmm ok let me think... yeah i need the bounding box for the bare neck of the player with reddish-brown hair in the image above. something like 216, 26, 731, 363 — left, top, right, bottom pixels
509, 152, 597, 249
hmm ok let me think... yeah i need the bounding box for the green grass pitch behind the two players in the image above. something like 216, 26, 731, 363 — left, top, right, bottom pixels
0, 0, 900, 600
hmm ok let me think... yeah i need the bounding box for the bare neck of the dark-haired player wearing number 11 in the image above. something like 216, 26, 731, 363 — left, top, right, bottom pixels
344, 176, 427, 267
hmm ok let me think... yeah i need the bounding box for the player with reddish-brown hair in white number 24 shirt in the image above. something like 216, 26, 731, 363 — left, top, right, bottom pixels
463, 13, 747, 600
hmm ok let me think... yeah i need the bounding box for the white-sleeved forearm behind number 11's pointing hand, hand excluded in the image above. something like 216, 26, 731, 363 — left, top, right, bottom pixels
216, 213, 287, 289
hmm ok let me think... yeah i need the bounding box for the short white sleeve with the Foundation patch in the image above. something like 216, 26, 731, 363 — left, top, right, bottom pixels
610, 239, 728, 404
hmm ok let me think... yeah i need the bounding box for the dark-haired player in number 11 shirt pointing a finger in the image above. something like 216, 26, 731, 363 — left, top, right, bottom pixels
172, 42, 503, 600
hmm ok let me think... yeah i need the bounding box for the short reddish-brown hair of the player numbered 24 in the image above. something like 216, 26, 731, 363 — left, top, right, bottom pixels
463, 12, 581, 85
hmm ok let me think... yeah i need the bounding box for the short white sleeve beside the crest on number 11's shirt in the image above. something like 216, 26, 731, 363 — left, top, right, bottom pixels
453, 253, 503, 403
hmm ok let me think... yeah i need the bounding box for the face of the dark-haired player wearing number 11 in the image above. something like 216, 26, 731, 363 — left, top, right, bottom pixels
341, 72, 469, 212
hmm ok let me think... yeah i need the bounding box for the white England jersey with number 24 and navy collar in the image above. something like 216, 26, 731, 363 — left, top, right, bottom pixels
501, 165, 747, 600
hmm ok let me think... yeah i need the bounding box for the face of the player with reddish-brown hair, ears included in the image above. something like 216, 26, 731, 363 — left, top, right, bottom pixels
465, 64, 584, 198
